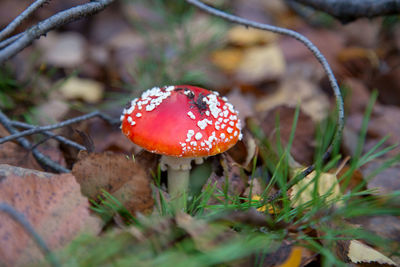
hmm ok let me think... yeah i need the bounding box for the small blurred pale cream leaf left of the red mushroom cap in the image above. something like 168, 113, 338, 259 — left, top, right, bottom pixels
59, 77, 104, 103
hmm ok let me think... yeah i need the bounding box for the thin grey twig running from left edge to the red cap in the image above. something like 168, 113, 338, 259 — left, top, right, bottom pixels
0, 111, 119, 144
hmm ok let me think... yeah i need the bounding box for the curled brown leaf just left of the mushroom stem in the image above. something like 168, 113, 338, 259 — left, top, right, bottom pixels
72, 151, 154, 215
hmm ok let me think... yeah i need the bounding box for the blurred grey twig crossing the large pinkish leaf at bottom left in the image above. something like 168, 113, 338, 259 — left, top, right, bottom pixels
0, 203, 61, 267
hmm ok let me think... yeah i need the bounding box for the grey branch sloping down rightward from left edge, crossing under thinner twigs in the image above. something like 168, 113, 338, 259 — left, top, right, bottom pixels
0, 110, 70, 173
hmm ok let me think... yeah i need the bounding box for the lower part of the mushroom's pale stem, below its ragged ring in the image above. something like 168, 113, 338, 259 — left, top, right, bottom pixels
168, 166, 190, 211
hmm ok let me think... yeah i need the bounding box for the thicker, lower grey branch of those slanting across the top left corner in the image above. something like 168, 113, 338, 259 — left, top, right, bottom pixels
0, 0, 114, 64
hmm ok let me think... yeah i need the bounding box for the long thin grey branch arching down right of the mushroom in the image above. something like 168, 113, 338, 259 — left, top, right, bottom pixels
186, 0, 344, 199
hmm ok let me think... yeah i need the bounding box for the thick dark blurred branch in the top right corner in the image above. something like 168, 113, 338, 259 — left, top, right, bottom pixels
291, 0, 400, 23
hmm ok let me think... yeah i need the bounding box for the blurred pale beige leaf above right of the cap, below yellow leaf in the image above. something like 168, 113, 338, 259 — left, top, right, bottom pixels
236, 44, 286, 84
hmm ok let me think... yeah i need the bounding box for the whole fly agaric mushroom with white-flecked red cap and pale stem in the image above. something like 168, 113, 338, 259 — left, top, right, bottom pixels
121, 85, 242, 208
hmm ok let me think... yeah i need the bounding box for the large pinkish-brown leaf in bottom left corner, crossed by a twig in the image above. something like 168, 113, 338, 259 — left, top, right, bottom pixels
0, 164, 101, 266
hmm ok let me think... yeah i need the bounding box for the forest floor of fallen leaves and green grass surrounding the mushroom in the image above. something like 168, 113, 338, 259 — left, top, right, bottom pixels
0, 0, 400, 266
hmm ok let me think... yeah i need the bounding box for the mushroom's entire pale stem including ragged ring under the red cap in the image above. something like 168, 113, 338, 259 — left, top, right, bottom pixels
161, 156, 203, 210
